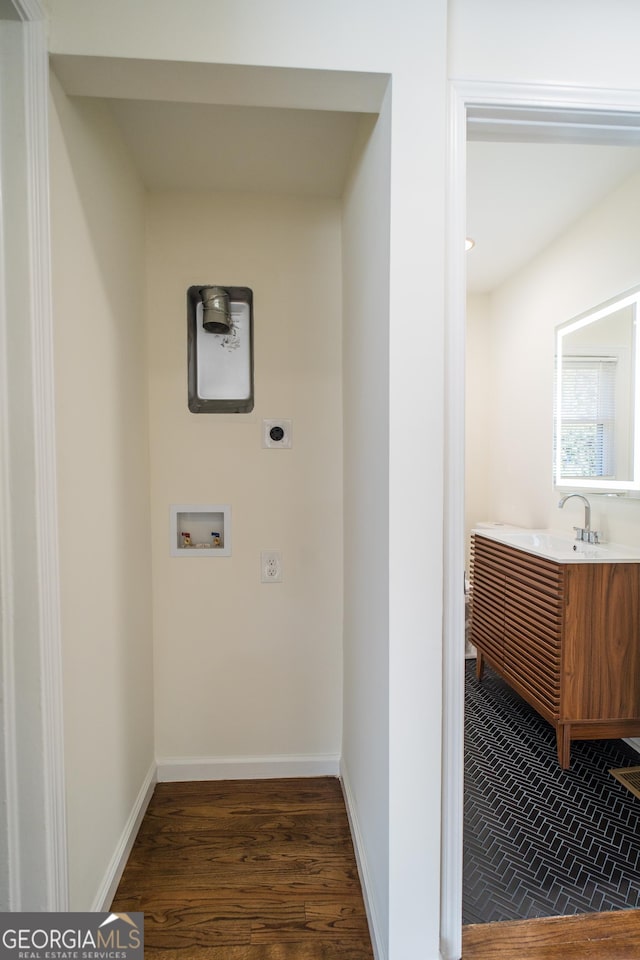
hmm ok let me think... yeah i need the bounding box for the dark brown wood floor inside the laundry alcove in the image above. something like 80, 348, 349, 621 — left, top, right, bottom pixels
112, 777, 373, 960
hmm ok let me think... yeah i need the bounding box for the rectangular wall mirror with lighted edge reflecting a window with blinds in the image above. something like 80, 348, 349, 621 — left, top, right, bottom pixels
554, 287, 640, 493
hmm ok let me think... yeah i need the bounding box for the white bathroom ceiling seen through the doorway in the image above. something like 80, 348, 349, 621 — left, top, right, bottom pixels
466, 141, 640, 292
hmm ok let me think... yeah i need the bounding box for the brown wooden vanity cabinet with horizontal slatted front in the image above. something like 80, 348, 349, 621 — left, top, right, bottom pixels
470, 534, 640, 769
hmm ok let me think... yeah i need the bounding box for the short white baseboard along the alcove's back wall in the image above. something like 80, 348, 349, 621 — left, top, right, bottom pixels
157, 754, 340, 783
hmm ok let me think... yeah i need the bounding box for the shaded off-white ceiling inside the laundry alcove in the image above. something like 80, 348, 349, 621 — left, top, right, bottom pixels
108, 99, 363, 197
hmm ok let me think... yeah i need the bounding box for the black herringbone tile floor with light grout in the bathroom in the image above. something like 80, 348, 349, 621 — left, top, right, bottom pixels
463, 660, 640, 923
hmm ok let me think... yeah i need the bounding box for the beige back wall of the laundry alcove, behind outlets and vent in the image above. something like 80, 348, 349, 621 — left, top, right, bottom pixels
147, 194, 342, 775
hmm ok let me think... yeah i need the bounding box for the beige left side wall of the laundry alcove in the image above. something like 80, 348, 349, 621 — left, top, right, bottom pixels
50, 78, 153, 910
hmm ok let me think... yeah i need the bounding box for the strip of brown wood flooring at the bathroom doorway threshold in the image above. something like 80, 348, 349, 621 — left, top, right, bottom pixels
462, 910, 640, 960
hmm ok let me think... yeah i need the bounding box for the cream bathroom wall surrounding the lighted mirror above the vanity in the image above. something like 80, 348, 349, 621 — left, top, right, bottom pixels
467, 170, 640, 545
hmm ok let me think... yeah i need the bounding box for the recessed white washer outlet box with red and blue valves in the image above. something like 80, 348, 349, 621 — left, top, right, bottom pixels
169, 504, 231, 559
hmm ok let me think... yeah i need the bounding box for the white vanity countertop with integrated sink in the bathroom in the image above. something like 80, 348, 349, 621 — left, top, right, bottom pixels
473, 527, 640, 563
